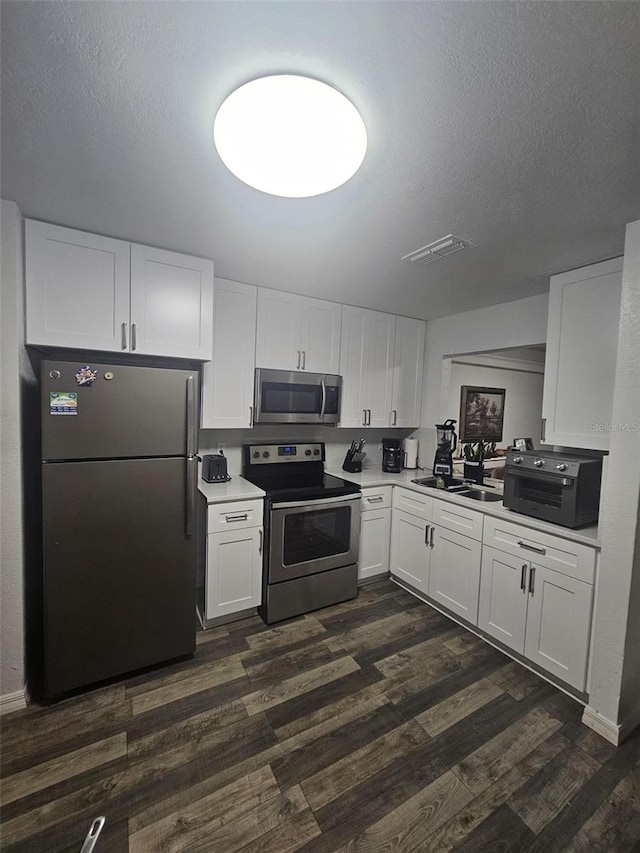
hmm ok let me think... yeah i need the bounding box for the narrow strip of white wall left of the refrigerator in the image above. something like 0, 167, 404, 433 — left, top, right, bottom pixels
0, 201, 25, 712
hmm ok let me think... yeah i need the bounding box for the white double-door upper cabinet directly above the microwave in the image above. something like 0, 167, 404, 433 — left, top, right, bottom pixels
256, 287, 342, 374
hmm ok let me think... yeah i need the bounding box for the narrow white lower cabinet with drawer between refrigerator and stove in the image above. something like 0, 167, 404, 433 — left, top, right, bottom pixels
203, 500, 263, 622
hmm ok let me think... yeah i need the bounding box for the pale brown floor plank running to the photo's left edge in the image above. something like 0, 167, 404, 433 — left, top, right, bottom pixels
0, 732, 127, 807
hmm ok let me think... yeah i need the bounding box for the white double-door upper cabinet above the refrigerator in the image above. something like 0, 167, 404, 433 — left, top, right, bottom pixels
25, 220, 213, 361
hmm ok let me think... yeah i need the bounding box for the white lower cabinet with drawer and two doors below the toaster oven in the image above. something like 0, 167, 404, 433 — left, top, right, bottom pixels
478, 518, 595, 691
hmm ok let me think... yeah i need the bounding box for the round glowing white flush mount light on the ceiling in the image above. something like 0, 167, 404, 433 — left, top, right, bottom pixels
213, 74, 367, 198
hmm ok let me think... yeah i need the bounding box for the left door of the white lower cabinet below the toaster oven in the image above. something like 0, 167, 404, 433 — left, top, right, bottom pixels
478, 546, 529, 654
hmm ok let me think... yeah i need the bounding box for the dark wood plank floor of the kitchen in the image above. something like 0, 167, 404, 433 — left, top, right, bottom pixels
0, 581, 640, 853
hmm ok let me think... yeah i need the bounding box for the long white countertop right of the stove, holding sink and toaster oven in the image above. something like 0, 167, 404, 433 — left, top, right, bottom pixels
327, 467, 600, 548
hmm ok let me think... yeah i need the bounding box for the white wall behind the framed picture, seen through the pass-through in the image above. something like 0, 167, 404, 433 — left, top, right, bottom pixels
447, 359, 544, 447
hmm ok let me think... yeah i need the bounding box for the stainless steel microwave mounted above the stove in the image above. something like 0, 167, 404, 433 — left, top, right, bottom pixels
253, 367, 342, 425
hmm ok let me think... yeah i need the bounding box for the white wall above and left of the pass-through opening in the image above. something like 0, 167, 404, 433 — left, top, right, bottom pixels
416, 293, 549, 467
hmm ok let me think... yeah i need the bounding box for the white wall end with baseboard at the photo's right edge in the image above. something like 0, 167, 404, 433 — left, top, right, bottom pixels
584, 220, 640, 742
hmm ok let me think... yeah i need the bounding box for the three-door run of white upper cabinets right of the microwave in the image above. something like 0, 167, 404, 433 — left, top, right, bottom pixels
340, 305, 425, 427
